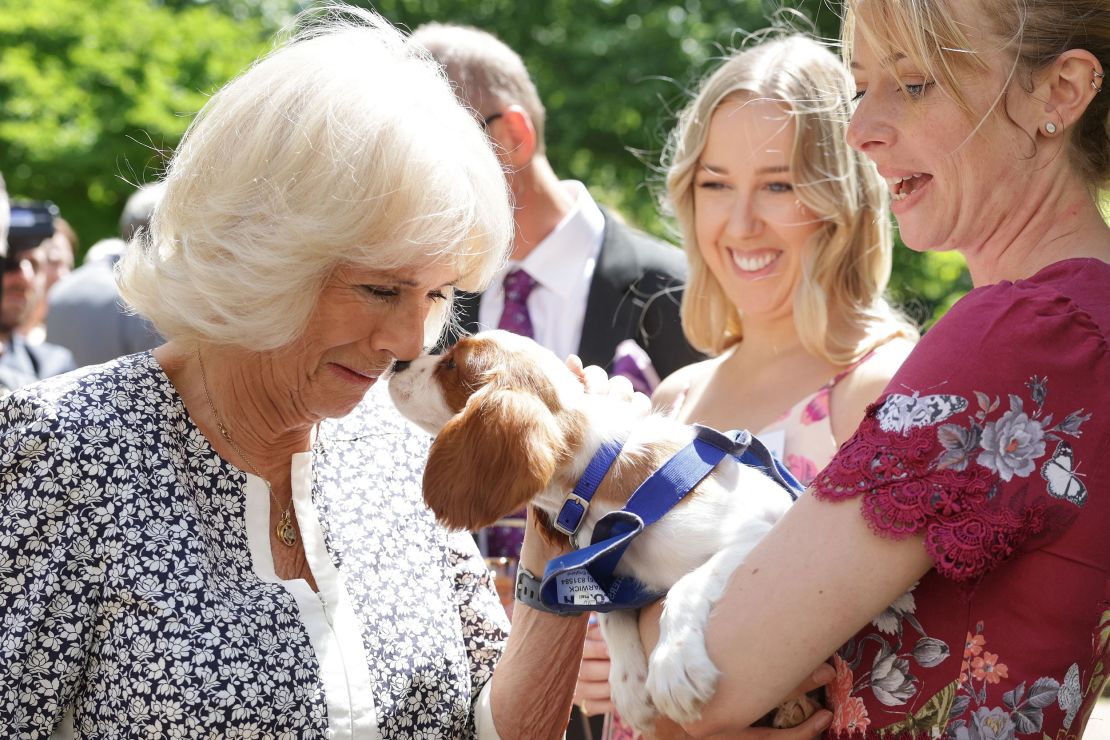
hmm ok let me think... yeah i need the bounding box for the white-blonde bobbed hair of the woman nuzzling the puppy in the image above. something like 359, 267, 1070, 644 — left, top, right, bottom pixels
119, 8, 513, 351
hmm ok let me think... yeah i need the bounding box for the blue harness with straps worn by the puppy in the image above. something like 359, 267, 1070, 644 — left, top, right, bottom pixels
539, 424, 804, 615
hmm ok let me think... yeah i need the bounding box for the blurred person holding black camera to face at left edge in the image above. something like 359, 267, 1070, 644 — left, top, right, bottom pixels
0, 202, 75, 388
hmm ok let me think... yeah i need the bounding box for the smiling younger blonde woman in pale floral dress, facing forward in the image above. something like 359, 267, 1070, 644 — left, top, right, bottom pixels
655, 36, 917, 483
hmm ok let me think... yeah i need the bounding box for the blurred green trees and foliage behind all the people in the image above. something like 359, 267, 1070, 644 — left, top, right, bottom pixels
0, 0, 970, 323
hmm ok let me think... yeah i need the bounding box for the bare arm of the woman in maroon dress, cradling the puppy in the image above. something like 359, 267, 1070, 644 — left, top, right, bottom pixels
670, 494, 932, 738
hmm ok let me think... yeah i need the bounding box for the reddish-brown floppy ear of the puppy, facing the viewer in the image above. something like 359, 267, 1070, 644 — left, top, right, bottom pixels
424, 389, 563, 530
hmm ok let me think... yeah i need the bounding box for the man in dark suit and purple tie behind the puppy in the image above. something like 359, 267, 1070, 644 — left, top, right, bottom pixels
413, 23, 699, 740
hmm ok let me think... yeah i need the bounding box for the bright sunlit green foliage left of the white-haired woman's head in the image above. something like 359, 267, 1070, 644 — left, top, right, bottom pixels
0, 0, 271, 246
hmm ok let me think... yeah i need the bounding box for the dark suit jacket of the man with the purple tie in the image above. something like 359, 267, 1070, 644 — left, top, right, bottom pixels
448, 209, 703, 378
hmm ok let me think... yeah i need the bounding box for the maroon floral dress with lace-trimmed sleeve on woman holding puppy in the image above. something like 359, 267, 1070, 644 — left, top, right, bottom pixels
813, 260, 1110, 740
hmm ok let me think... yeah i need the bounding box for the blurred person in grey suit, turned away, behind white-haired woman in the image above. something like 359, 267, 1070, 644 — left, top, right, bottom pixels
47, 183, 164, 366
